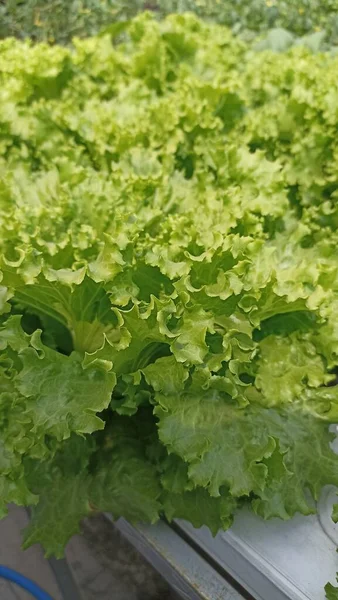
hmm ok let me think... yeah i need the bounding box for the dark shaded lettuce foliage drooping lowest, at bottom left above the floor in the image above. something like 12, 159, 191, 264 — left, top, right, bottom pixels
24, 420, 161, 558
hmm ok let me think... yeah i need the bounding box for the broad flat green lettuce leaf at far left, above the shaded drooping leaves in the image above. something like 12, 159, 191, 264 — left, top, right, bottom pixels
17, 333, 116, 439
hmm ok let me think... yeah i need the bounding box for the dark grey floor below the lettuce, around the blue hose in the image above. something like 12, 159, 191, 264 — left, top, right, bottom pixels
0, 507, 177, 600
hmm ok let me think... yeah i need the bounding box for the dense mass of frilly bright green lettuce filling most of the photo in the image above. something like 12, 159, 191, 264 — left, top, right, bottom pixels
0, 14, 338, 580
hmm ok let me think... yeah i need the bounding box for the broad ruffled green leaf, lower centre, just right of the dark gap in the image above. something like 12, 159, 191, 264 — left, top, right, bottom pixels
155, 380, 275, 496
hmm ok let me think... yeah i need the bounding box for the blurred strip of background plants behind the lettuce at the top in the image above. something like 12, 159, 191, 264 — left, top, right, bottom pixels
0, 0, 338, 45
